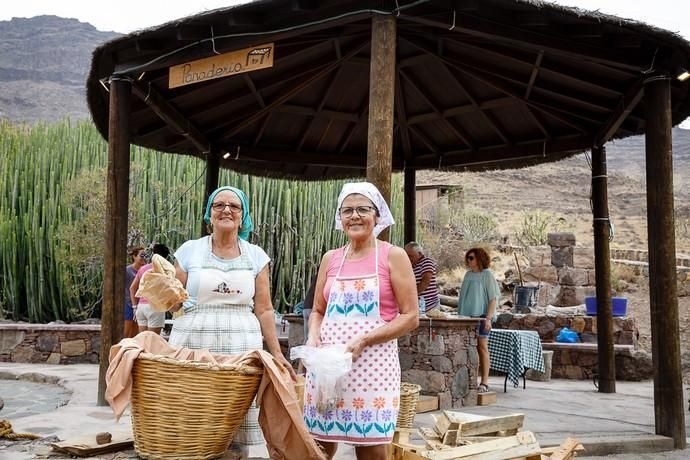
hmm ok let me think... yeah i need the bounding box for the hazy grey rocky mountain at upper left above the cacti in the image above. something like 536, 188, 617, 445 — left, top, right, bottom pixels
0, 16, 120, 122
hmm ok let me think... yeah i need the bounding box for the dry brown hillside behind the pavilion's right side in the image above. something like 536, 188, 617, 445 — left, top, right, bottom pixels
417, 128, 690, 254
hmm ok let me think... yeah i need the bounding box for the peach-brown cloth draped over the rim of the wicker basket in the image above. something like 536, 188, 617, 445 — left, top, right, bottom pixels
105, 331, 326, 460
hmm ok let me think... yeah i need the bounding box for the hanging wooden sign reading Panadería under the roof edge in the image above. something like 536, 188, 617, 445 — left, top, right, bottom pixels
168, 43, 274, 88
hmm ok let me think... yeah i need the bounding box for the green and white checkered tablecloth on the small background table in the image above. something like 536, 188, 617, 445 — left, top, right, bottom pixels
489, 329, 544, 387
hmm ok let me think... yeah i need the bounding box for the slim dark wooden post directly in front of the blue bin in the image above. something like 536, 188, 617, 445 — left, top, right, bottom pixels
592, 145, 616, 393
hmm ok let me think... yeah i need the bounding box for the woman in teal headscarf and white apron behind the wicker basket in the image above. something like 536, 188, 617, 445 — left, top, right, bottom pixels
170, 187, 294, 454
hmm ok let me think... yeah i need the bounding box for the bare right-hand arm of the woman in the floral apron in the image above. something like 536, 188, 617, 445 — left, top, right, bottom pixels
346, 247, 419, 361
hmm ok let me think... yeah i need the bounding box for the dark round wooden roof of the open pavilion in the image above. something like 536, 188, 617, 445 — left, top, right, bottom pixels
87, 0, 690, 179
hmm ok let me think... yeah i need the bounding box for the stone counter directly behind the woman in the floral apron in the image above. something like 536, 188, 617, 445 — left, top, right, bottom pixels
283, 315, 479, 409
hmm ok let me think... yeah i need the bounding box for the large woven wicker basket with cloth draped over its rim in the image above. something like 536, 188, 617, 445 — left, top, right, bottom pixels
132, 353, 263, 460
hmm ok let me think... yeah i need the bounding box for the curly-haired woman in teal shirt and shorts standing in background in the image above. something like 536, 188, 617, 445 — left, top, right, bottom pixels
458, 248, 500, 393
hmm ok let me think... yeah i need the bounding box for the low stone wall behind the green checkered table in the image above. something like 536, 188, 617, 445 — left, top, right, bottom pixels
493, 313, 639, 346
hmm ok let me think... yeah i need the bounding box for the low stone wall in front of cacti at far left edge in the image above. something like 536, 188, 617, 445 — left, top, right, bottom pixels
0, 323, 101, 364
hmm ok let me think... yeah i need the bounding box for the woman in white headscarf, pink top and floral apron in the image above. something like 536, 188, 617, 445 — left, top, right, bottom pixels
304, 182, 419, 460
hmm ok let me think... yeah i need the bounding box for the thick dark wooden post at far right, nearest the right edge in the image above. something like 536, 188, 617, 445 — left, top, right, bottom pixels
644, 75, 687, 449
